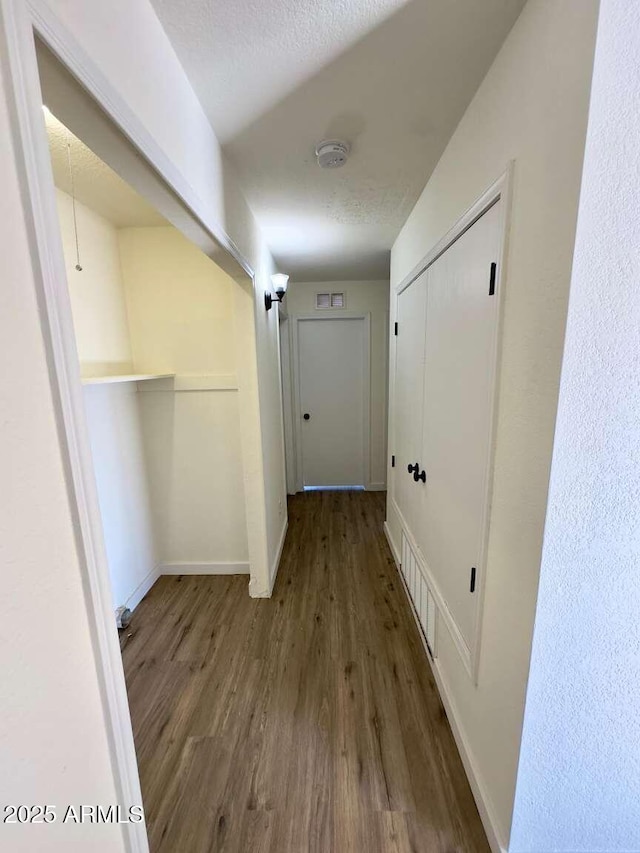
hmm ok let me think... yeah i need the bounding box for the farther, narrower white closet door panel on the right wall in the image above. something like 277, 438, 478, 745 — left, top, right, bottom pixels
394, 272, 427, 535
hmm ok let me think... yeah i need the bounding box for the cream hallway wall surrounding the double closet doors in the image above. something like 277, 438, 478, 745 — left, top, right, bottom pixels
388, 5, 597, 846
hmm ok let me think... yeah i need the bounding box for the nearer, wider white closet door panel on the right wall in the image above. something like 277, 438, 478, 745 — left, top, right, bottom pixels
413, 202, 502, 649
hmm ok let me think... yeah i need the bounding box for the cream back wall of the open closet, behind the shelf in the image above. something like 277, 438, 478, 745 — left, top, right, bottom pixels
118, 226, 249, 572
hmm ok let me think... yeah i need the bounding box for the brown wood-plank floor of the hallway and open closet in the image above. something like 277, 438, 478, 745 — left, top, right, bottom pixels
123, 492, 489, 853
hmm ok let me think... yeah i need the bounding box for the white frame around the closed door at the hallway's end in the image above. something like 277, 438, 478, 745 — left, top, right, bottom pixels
290, 311, 371, 492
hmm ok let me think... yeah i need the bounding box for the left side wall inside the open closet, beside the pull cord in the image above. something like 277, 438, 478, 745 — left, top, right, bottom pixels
56, 190, 158, 610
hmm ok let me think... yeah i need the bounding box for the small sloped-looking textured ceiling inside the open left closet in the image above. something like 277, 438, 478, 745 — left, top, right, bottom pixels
44, 110, 167, 228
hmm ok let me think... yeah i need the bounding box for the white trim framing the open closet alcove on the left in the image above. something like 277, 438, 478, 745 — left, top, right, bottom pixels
0, 0, 266, 853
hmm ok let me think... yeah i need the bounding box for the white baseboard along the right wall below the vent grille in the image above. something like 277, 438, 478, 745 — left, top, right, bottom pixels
384, 540, 507, 853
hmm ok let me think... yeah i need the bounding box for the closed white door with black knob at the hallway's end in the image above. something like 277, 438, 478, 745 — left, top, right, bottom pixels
297, 317, 369, 486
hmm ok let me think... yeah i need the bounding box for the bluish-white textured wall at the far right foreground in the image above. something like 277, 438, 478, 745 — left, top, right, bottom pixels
510, 0, 640, 853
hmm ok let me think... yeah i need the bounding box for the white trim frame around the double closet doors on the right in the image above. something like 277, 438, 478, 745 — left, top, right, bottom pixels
388, 168, 514, 685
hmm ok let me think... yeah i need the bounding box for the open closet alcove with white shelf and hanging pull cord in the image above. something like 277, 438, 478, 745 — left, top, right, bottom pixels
45, 110, 250, 609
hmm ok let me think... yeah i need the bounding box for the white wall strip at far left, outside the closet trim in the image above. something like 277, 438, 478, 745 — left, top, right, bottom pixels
0, 64, 125, 853
